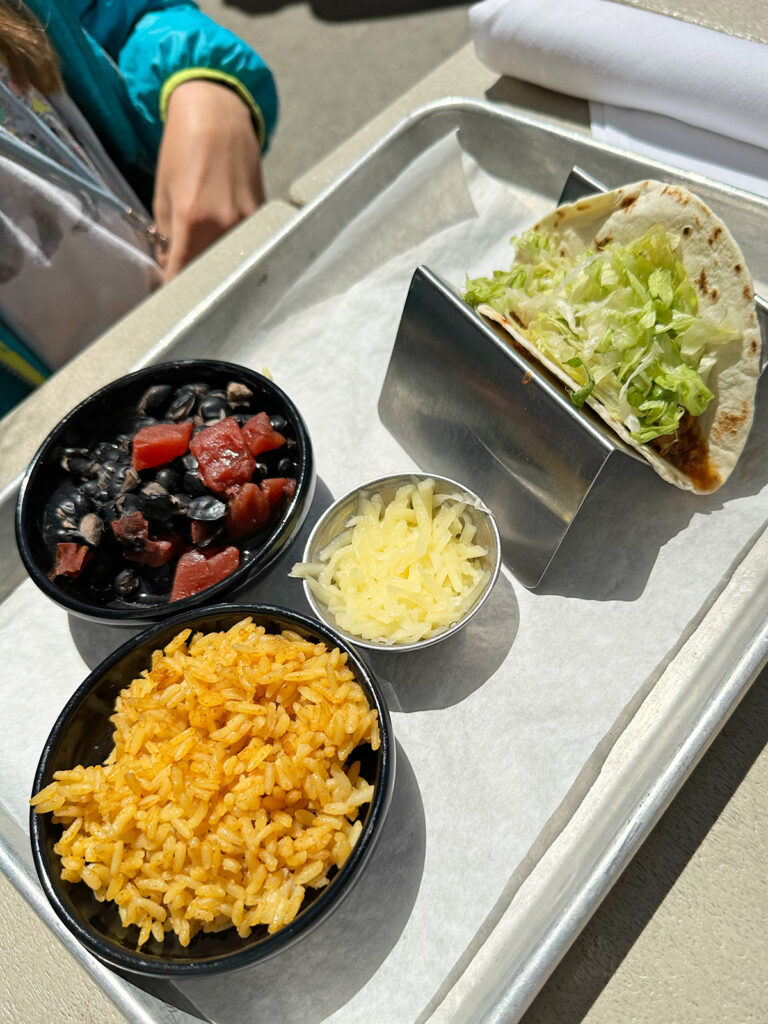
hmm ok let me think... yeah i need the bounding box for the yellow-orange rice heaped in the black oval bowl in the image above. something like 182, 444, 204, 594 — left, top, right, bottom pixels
32, 618, 380, 947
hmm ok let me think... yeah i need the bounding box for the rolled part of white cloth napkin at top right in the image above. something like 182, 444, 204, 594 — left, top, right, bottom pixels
469, 0, 768, 146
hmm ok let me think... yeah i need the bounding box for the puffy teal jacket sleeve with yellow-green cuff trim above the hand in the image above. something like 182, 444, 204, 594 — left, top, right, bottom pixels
76, 0, 278, 150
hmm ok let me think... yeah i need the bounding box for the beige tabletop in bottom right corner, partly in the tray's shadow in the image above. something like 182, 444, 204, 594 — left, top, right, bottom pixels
521, 671, 768, 1024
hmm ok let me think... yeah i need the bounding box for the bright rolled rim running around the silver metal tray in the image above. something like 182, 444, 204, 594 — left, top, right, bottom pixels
0, 96, 768, 1024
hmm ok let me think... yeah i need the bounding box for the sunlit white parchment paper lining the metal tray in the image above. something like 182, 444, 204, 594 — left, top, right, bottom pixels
0, 137, 768, 1024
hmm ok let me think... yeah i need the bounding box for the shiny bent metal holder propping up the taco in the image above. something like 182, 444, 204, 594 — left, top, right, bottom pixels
379, 166, 768, 589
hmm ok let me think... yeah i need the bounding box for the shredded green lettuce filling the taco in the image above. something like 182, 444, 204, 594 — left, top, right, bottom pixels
465, 224, 740, 443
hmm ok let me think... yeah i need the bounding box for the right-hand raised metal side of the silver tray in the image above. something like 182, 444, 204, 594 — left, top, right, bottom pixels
428, 528, 768, 1024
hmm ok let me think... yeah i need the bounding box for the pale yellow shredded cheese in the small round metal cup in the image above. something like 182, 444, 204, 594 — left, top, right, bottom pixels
290, 479, 490, 644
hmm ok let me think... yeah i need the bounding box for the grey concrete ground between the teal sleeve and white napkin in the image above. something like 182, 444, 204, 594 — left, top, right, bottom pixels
200, 0, 469, 199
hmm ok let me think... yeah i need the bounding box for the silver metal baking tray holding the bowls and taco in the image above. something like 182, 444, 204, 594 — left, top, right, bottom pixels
0, 99, 768, 1024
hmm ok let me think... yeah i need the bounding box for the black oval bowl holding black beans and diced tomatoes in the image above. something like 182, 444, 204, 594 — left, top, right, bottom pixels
15, 359, 314, 626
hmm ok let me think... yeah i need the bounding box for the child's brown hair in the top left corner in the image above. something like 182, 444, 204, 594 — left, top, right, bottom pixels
0, 0, 62, 92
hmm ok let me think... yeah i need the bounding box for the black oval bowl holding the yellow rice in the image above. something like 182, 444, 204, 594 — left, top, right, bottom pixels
30, 604, 394, 978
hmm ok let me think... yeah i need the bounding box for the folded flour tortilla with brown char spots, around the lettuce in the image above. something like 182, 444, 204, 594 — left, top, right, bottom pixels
478, 181, 760, 494
